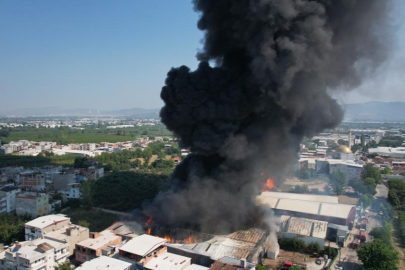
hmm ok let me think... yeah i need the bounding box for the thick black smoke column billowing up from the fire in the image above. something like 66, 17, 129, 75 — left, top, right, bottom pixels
148, 0, 390, 232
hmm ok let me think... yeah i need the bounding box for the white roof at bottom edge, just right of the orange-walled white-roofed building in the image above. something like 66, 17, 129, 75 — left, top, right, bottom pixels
145, 252, 191, 270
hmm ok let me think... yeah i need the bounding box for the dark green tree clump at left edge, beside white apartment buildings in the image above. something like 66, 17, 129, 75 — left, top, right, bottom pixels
0, 213, 28, 245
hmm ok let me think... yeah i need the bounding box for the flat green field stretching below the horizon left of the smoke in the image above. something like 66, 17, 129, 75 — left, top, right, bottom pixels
0, 125, 172, 144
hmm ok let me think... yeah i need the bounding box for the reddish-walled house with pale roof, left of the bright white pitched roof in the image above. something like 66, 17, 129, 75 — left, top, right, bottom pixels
75, 230, 122, 263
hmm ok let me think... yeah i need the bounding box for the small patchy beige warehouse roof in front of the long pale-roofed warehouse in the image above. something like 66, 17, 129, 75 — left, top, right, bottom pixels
279, 215, 328, 239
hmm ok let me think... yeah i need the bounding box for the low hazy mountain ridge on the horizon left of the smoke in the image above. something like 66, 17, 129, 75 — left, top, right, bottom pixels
0, 107, 160, 118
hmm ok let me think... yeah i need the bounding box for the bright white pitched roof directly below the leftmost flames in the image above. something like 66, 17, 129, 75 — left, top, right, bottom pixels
120, 234, 166, 257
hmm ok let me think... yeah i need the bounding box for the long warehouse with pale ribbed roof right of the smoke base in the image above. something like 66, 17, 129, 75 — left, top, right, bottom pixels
256, 192, 356, 226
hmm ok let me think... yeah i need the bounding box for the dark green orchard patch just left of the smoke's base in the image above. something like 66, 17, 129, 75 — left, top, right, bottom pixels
94, 172, 168, 211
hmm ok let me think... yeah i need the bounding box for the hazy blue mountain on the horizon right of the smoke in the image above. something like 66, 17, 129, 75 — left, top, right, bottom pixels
342, 101, 405, 121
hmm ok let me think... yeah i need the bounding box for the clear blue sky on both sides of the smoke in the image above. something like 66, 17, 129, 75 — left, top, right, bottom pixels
0, 0, 405, 110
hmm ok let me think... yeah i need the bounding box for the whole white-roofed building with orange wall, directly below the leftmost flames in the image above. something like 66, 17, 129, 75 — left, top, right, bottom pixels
119, 234, 167, 269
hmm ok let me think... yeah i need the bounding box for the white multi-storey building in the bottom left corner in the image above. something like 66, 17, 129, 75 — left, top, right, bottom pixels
0, 239, 69, 270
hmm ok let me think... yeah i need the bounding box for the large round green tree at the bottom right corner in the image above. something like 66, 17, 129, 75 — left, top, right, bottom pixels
357, 239, 399, 270
